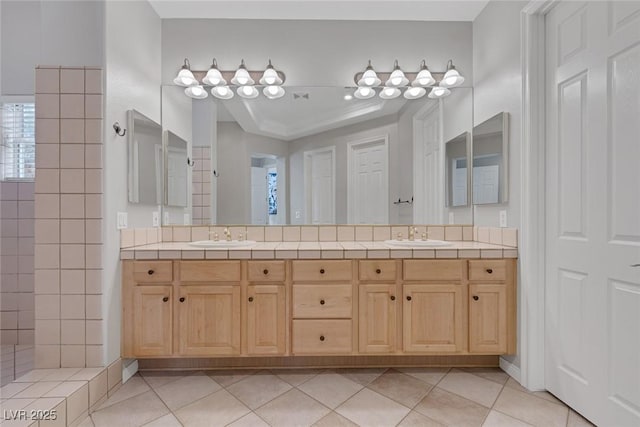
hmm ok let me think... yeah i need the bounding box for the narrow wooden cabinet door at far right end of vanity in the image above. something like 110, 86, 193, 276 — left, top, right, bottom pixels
469, 284, 507, 354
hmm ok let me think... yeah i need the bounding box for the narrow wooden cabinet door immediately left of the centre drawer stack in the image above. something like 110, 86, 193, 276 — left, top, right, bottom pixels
247, 285, 287, 354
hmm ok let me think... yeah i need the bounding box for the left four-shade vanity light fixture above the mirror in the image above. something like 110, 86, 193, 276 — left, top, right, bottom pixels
173, 58, 286, 99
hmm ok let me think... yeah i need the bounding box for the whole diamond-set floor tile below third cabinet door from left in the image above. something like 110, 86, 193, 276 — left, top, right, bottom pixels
227, 371, 291, 409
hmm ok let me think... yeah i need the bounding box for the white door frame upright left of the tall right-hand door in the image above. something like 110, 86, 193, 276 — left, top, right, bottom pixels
516, 0, 557, 390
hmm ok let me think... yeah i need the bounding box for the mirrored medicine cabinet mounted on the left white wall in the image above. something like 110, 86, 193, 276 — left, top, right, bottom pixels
127, 110, 162, 205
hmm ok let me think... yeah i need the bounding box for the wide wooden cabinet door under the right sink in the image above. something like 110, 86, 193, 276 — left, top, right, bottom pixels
402, 284, 465, 353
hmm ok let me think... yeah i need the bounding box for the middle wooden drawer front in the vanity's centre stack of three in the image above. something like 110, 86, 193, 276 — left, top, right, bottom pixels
293, 285, 353, 318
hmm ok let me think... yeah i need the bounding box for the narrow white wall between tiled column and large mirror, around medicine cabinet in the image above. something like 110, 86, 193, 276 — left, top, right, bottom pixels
103, 1, 161, 363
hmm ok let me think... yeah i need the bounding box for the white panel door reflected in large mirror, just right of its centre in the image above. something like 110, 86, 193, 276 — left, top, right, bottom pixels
347, 138, 389, 224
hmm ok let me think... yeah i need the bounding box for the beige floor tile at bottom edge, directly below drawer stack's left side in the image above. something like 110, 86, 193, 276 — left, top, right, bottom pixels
256, 389, 331, 427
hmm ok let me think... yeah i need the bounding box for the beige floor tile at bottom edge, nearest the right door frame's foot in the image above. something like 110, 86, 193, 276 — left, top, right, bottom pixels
494, 387, 569, 427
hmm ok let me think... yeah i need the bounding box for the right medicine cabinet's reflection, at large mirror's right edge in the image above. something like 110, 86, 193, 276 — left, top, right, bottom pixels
445, 132, 471, 207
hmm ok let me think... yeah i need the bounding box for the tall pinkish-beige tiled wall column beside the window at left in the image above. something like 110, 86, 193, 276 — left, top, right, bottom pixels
35, 67, 104, 368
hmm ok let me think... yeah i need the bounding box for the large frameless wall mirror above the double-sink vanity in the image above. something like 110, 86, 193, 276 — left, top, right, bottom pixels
162, 86, 473, 225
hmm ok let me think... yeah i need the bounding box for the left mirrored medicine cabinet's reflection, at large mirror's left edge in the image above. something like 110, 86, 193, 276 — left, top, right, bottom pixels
165, 131, 189, 207
